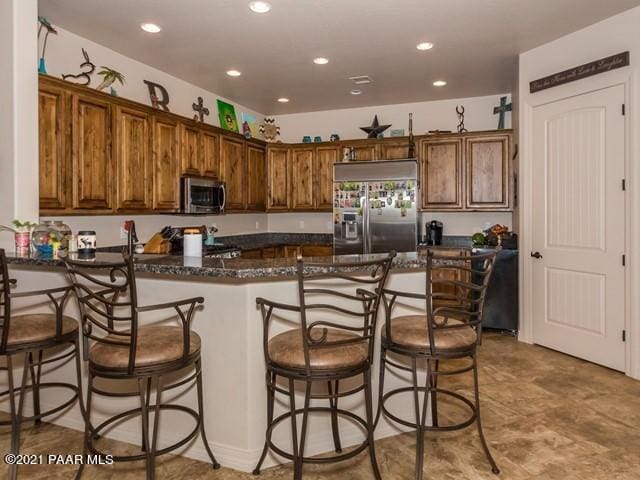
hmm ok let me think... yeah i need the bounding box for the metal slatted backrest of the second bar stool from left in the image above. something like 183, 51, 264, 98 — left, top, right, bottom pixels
62, 256, 138, 373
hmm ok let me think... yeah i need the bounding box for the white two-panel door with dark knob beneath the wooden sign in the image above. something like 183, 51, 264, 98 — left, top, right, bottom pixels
526, 85, 625, 370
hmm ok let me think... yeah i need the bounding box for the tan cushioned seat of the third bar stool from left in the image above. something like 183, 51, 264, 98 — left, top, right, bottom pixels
269, 328, 369, 370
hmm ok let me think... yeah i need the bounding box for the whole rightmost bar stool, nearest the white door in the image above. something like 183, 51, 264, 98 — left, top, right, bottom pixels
376, 251, 500, 480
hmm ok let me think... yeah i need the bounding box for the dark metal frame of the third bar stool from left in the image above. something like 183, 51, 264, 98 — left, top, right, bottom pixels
253, 252, 396, 480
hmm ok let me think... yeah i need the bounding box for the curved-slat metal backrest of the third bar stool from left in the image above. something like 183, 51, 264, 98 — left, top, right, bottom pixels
297, 252, 396, 372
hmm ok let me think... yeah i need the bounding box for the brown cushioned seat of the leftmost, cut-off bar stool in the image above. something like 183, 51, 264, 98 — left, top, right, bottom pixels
7, 313, 78, 346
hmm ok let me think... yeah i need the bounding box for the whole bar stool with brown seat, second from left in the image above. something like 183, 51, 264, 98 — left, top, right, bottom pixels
63, 256, 220, 480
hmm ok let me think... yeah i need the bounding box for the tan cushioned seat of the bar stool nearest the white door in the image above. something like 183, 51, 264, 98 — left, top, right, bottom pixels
382, 315, 478, 350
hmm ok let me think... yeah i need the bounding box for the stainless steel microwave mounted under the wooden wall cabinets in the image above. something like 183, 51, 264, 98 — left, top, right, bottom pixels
180, 177, 226, 215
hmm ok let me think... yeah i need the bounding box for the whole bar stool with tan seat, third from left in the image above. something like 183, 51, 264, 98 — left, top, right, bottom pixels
253, 253, 395, 480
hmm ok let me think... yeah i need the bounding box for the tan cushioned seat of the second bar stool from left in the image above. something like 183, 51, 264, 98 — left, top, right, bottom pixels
89, 326, 201, 370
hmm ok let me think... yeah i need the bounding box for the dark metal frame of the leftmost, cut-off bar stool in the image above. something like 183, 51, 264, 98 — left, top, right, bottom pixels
0, 249, 84, 480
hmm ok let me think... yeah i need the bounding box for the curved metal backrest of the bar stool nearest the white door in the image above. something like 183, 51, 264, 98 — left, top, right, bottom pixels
426, 250, 498, 354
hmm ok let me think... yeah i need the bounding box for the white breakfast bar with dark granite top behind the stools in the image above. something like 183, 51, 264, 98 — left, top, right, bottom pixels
0, 252, 442, 471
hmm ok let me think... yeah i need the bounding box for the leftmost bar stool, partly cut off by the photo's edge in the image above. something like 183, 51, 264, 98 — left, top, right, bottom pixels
0, 249, 84, 479
